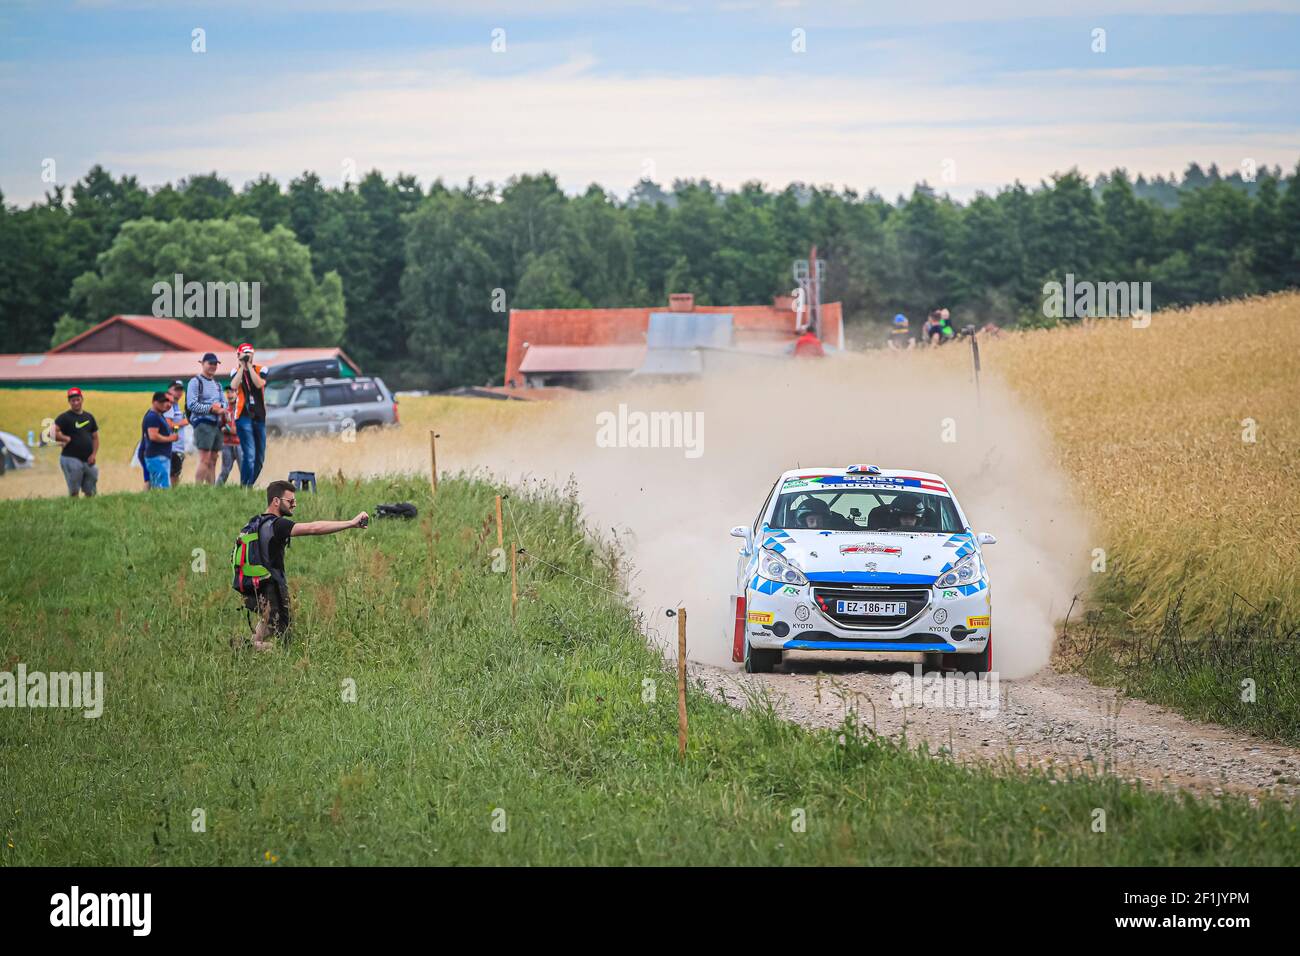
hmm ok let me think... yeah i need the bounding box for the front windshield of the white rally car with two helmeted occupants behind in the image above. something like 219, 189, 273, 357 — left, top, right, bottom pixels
768, 488, 965, 535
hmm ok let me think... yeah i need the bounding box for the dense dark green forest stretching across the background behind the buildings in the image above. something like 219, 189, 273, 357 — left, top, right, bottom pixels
0, 164, 1300, 390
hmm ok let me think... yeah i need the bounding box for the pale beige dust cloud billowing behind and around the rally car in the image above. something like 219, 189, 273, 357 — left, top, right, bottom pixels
282, 352, 1088, 679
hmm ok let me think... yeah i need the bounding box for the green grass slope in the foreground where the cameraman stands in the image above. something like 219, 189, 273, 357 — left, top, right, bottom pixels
0, 479, 1300, 865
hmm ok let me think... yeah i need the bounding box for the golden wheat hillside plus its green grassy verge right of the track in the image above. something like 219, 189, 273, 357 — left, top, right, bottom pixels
967, 293, 1300, 743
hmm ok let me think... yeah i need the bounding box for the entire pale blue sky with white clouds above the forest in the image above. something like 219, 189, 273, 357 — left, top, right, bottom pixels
0, 0, 1300, 203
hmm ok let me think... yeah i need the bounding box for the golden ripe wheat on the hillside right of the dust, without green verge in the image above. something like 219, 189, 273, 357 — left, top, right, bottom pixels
977, 293, 1300, 627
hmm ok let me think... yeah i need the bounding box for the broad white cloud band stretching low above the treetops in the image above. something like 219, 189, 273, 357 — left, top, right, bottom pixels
73, 53, 1300, 196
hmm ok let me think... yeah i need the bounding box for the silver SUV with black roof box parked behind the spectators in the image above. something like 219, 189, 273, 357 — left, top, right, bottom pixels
267, 377, 398, 438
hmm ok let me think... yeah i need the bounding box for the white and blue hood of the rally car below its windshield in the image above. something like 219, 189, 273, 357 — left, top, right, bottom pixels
759, 528, 975, 584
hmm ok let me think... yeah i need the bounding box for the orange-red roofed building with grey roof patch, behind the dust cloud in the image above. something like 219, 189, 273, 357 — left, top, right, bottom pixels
506, 293, 844, 388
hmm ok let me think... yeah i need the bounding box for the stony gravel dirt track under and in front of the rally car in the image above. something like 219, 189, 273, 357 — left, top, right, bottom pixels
690, 661, 1300, 800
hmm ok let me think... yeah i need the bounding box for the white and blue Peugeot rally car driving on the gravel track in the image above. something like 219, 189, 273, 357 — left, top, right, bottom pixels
731, 464, 997, 672
